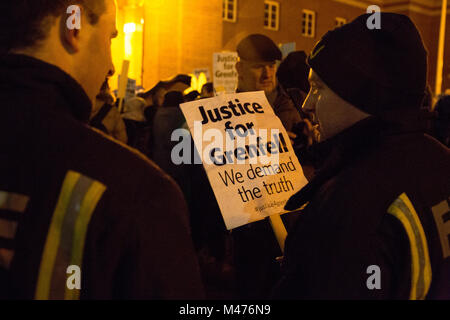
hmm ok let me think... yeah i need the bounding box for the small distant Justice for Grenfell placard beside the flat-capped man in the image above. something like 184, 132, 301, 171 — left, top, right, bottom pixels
213, 52, 238, 93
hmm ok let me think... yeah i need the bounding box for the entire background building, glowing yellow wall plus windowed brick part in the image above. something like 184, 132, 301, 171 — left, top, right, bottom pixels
110, 0, 450, 91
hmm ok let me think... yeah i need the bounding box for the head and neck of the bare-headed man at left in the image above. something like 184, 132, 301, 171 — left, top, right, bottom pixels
0, 0, 117, 102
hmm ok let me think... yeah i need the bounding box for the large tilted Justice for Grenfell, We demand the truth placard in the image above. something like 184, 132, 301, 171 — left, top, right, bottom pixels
179, 91, 307, 230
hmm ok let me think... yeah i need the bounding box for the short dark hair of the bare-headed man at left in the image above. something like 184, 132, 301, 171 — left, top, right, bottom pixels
0, 0, 106, 53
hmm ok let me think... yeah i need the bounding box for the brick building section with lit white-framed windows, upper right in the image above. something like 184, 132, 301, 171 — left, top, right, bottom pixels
222, 0, 450, 91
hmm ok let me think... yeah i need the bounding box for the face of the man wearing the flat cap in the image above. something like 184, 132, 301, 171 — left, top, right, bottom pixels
236, 60, 277, 94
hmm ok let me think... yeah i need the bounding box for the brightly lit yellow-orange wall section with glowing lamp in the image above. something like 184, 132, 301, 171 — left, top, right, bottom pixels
110, 0, 222, 94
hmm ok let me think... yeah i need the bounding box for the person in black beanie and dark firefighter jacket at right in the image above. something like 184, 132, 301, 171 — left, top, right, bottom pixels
273, 13, 450, 299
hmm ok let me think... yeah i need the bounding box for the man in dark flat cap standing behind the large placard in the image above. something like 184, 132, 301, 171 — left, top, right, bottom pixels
232, 34, 301, 299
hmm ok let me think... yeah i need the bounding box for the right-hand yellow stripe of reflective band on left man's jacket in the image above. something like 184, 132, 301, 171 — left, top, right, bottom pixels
65, 181, 106, 300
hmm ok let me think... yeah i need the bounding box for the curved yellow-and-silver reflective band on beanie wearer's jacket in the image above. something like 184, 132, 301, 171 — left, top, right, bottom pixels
388, 193, 432, 300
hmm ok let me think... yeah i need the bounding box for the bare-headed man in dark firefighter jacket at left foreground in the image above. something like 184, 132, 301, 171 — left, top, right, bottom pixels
0, 0, 204, 300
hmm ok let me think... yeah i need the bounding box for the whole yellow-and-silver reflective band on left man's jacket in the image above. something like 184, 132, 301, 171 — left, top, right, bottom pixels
35, 171, 106, 300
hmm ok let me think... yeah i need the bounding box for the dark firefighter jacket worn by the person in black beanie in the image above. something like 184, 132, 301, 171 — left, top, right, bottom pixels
273, 117, 450, 299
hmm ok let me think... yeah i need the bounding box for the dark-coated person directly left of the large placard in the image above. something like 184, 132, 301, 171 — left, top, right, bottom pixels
156, 91, 236, 300
